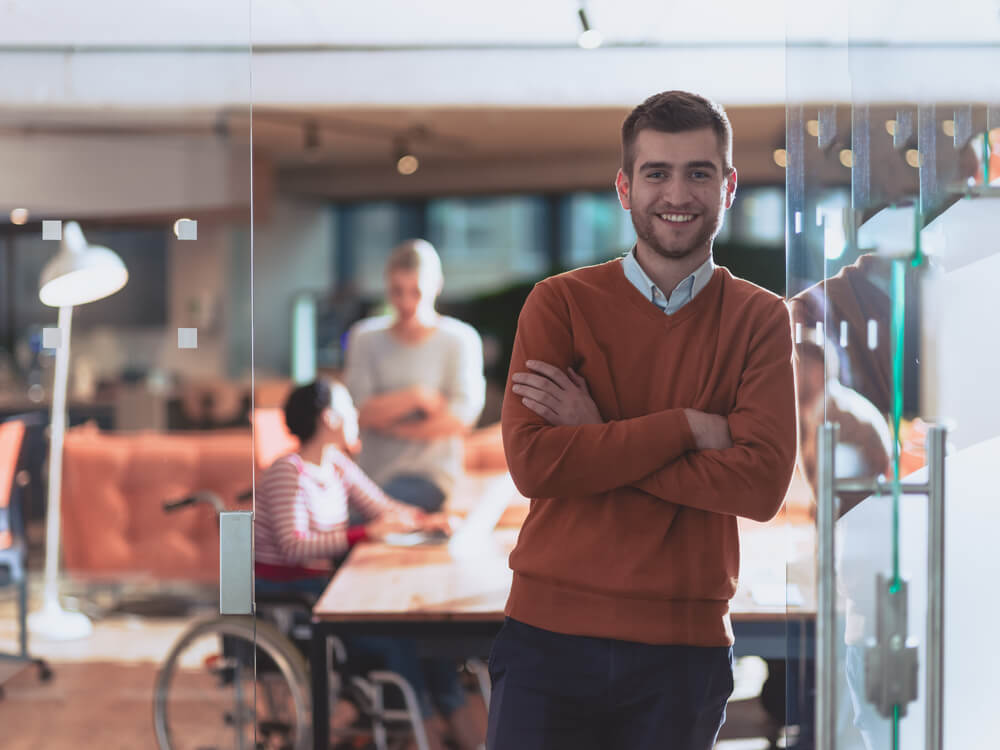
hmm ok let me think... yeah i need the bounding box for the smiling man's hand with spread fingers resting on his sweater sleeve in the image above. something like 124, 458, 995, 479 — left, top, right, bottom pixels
511, 359, 604, 425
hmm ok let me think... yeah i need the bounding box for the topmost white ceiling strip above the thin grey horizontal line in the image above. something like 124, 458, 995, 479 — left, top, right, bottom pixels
0, 0, 1000, 46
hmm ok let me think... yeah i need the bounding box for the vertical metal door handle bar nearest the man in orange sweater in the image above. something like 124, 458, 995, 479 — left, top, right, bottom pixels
816, 422, 840, 750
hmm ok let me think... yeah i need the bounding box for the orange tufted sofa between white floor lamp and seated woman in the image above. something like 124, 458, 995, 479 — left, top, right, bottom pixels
62, 425, 253, 582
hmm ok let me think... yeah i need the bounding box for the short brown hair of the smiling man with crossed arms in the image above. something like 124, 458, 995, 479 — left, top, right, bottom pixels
622, 91, 733, 177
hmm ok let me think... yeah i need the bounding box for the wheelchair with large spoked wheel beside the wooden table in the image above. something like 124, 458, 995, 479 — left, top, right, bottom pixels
153, 492, 488, 750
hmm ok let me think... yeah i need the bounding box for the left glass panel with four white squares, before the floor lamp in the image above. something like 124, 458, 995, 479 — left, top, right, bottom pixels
0, 5, 255, 750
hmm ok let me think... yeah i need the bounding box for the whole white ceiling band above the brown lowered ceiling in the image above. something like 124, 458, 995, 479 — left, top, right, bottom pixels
0, 0, 1000, 111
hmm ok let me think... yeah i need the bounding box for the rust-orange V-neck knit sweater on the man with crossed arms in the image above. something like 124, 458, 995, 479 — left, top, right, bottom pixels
503, 261, 796, 646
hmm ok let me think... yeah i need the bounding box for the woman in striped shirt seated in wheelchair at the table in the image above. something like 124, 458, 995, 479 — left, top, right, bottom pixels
254, 380, 464, 750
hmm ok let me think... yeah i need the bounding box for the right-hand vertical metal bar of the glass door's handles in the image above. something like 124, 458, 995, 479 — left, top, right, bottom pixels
925, 425, 947, 750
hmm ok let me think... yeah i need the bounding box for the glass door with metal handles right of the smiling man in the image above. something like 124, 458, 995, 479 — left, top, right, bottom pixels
786, 7, 1000, 750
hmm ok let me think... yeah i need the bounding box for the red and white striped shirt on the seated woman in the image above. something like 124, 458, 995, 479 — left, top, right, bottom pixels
254, 448, 391, 572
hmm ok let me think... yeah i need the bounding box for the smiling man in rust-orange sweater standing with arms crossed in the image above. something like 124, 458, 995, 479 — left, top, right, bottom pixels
487, 91, 796, 750
